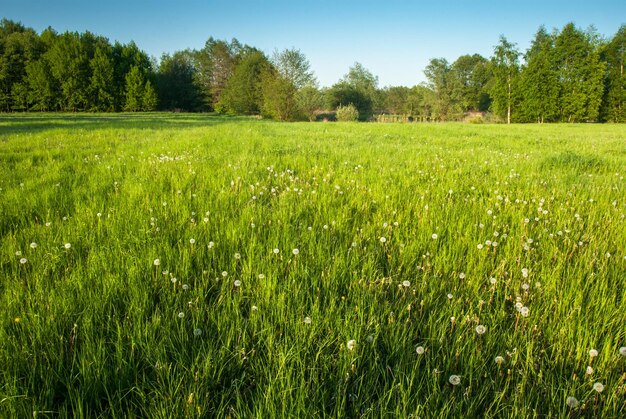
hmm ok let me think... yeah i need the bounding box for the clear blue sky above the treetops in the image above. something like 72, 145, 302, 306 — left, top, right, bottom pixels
0, 0, 626, 87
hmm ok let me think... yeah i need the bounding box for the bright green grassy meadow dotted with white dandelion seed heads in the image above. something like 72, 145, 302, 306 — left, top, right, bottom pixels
0, 114, 626, 418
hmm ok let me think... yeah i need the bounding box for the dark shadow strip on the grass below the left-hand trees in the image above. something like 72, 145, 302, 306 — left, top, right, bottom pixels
0, 113, 253, 136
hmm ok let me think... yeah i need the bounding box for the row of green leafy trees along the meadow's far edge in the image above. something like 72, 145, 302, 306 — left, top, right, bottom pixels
0, 19, 626, 123
